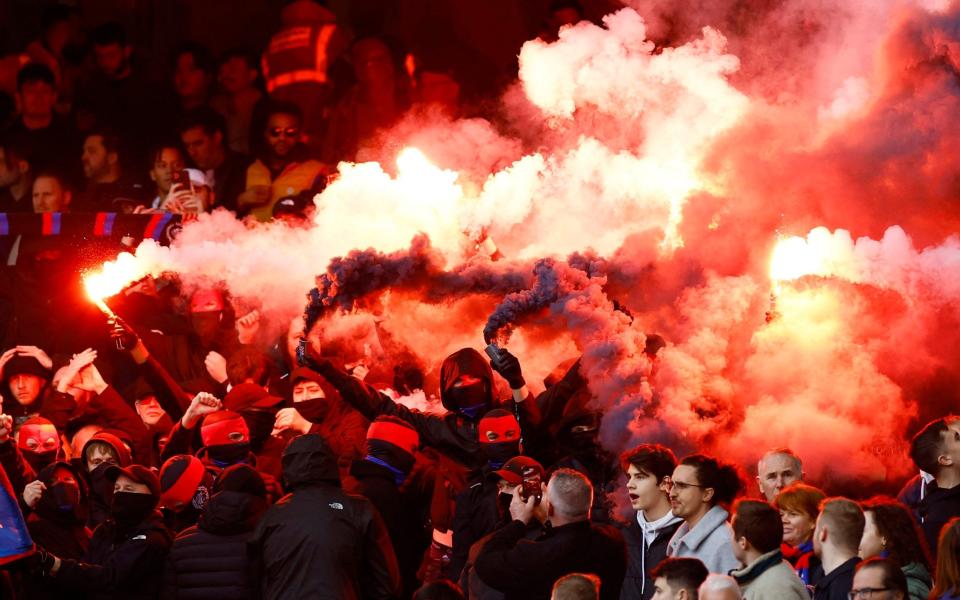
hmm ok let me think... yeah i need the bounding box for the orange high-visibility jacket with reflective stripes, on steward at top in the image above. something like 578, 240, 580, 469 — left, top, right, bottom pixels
261, 23, 337, 93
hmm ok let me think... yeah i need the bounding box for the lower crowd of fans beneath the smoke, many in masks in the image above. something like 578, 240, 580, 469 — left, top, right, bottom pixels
0, 292, 960, 600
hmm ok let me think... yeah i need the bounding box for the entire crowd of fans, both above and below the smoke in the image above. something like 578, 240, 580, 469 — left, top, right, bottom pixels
0, 0, 960, 600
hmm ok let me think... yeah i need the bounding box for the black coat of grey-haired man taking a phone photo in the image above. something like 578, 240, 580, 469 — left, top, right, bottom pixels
475, 521, 627, 600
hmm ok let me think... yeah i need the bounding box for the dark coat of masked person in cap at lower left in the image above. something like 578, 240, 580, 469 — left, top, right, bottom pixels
55, 513, 173, 599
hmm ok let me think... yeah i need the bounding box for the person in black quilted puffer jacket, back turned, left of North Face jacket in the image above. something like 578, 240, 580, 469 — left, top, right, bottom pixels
164, 464, 267, 600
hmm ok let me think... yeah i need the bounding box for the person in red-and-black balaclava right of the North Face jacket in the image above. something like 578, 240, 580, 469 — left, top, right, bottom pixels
344, 417, 430, 598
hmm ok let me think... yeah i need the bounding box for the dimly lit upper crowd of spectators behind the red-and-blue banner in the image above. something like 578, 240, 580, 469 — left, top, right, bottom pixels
0, 0, 583, 221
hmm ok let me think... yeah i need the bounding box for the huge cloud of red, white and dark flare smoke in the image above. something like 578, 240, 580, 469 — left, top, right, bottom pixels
84, 0, 960, 483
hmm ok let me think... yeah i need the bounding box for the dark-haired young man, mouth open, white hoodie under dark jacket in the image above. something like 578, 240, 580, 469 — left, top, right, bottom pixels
620, 444, 688, 600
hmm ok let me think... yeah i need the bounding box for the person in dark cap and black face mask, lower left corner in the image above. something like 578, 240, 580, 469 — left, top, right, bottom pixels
51, 465, 173, 598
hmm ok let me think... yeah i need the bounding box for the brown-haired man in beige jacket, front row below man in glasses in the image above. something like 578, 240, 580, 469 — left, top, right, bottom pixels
730, 500, 810, 600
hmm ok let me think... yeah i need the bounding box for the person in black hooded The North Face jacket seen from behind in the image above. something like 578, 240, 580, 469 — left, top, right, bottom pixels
251, 434, 400, 599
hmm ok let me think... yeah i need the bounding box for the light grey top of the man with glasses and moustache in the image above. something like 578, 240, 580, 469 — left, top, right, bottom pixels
667, 506, 740, 575
